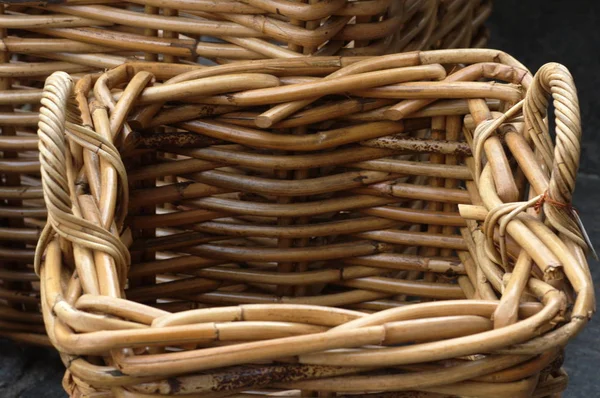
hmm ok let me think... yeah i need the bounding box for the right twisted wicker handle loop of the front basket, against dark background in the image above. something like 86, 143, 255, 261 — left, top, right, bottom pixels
523, 63, 588, 247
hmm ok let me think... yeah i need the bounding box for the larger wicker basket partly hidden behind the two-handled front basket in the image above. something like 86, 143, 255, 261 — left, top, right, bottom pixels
0, 0, 490, 343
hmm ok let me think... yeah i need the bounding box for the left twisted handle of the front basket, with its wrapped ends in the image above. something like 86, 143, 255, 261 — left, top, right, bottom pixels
34, 72, 129, 278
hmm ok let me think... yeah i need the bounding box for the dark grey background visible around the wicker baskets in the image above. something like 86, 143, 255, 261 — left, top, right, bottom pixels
0, 0, 600, 398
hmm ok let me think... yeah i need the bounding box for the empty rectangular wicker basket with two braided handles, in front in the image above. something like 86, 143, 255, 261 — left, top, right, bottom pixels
36, 49, 595, 398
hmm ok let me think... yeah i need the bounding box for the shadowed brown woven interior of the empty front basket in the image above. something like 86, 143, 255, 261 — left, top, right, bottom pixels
124, 77, 478, 311
